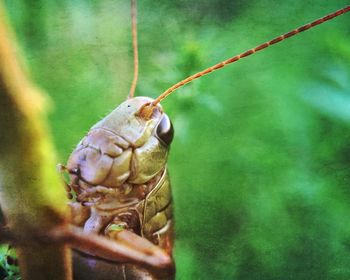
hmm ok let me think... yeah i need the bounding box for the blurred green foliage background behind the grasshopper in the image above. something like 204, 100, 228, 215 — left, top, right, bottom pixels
5, 0, 350, 280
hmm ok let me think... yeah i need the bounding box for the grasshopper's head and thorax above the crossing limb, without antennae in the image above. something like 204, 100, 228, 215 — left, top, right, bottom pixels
67, 97, 173, 278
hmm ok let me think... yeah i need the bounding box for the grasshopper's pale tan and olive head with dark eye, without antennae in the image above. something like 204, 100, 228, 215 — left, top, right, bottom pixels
67, 97, 173, 201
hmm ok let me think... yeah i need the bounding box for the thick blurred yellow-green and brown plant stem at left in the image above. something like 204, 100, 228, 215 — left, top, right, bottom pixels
0, 3, 72, 280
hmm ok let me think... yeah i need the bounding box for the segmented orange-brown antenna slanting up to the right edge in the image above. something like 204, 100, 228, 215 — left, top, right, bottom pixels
152, 6, 350, 106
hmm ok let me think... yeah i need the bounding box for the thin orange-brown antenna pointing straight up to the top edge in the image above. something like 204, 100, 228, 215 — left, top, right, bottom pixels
128, 0, 139, 98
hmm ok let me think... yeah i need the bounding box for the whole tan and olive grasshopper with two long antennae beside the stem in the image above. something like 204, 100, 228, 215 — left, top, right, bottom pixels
58, 0, 350, 279
